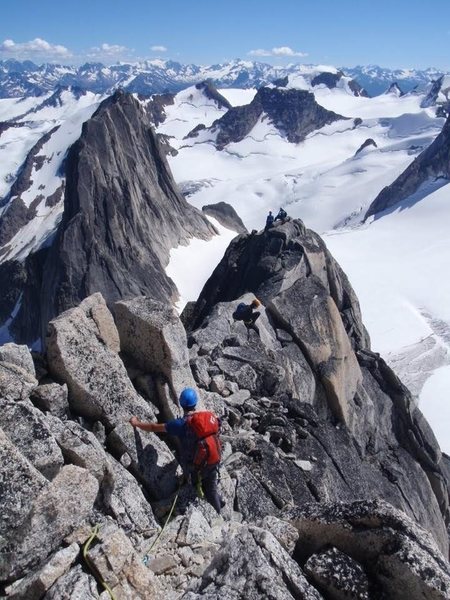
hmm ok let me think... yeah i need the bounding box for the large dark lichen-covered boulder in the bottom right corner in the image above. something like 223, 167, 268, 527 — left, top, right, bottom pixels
285, 501, 450, 600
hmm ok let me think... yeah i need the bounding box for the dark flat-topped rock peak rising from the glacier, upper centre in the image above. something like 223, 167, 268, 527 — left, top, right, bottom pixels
211, 88, 345, 150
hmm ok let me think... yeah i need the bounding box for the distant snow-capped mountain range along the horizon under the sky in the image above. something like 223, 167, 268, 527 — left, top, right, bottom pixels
0, 59, 443, 98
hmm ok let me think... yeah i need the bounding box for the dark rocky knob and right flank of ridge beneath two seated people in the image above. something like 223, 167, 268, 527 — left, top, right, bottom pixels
189, 221, 450, 554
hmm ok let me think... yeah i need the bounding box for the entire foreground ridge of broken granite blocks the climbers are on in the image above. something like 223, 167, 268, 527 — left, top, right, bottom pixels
0, 221, 450, 600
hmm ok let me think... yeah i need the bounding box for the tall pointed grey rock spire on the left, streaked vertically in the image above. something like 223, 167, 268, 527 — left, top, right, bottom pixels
0, 92, 215, 343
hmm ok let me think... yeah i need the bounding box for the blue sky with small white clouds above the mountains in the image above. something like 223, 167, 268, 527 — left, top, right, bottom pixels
0, 0, 450, 71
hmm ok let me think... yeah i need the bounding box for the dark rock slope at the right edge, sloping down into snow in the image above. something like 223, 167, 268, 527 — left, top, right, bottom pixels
364, 117, 450, 220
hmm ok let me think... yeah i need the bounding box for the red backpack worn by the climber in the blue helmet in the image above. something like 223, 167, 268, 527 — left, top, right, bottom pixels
186, 411, 222, 470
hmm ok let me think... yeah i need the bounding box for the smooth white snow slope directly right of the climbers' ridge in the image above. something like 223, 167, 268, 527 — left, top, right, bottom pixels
324, 183, 450, 454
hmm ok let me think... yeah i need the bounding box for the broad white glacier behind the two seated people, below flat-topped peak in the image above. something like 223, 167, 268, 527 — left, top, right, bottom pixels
166, 86, 443, 232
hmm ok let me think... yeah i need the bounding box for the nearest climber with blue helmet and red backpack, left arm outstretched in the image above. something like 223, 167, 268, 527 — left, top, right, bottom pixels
130, 388, 225, 513
